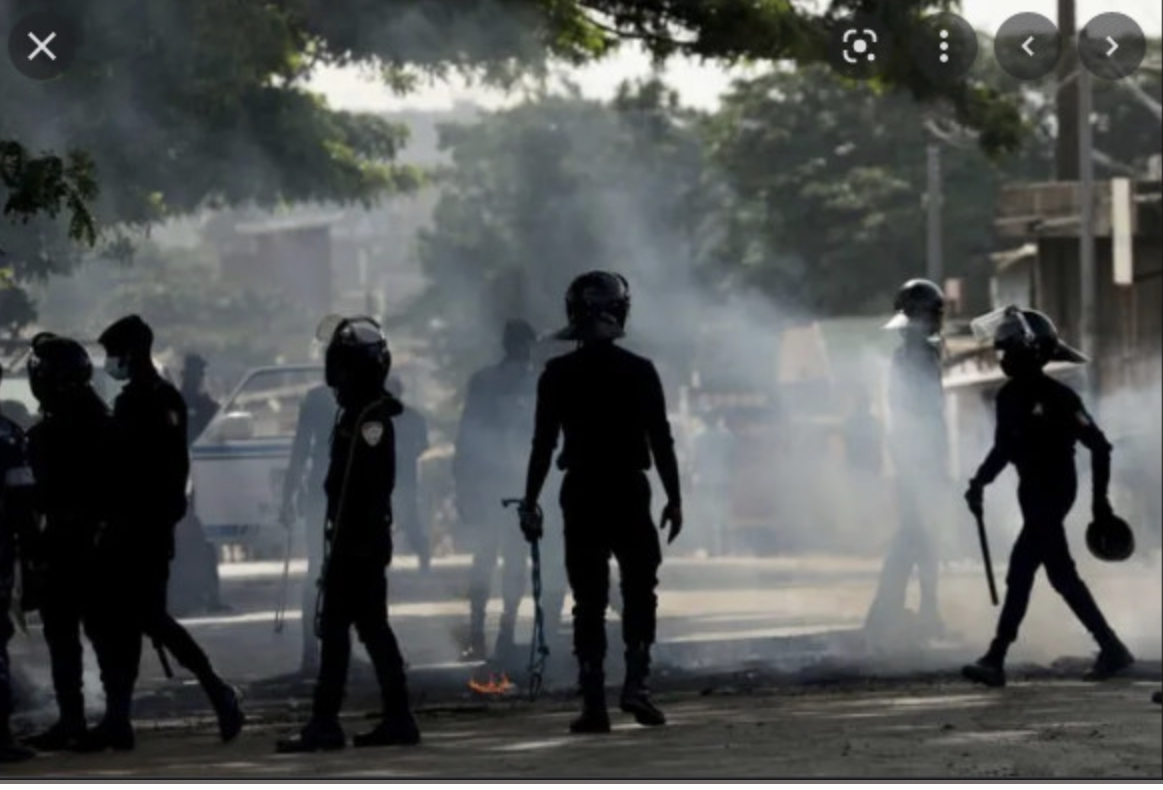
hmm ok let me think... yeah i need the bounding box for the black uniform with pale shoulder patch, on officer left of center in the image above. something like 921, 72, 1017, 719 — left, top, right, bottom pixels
312, 392, 407, 724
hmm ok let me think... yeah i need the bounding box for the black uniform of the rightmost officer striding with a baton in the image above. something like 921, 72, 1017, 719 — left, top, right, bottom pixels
972, 373, 1121, 662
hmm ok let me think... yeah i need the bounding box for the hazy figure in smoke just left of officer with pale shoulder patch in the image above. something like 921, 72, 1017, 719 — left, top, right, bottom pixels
280, 384, 338, 676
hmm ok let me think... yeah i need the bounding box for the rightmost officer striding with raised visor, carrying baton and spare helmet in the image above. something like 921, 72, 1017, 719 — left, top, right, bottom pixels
962, 307, 1134, 686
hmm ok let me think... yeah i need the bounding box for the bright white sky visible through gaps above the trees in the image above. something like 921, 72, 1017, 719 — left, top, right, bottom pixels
311, 0, 1161, 112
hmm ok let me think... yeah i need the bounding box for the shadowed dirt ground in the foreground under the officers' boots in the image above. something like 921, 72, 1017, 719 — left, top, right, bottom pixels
5, 678, 1163, 780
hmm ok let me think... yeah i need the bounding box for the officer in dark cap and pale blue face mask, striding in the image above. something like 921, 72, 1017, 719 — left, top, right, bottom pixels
84, 315, 243, 750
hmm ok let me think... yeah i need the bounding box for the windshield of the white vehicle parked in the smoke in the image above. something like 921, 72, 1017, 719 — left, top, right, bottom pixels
197, 368, 323, 444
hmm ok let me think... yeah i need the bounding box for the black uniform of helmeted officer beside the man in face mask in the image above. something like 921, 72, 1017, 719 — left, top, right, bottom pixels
28, 387, 114, 748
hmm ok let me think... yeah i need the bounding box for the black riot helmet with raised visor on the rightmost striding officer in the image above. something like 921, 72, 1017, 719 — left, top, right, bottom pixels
971, 305, 1087, 377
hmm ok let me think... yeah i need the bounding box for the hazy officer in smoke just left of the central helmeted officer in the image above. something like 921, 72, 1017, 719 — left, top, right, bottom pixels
452, 320, 536, 659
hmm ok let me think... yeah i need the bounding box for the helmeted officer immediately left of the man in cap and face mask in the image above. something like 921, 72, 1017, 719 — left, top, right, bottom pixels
28, 333, 114, 752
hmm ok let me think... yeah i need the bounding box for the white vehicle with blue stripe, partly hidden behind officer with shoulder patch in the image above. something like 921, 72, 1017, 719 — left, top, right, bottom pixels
190, 365, 323, 560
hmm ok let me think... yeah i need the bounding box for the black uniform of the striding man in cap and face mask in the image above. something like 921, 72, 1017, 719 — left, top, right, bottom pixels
102, 366, 242, 740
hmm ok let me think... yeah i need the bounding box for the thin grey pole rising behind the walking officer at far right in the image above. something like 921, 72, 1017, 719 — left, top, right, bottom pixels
1075, 69, 1099, 407
